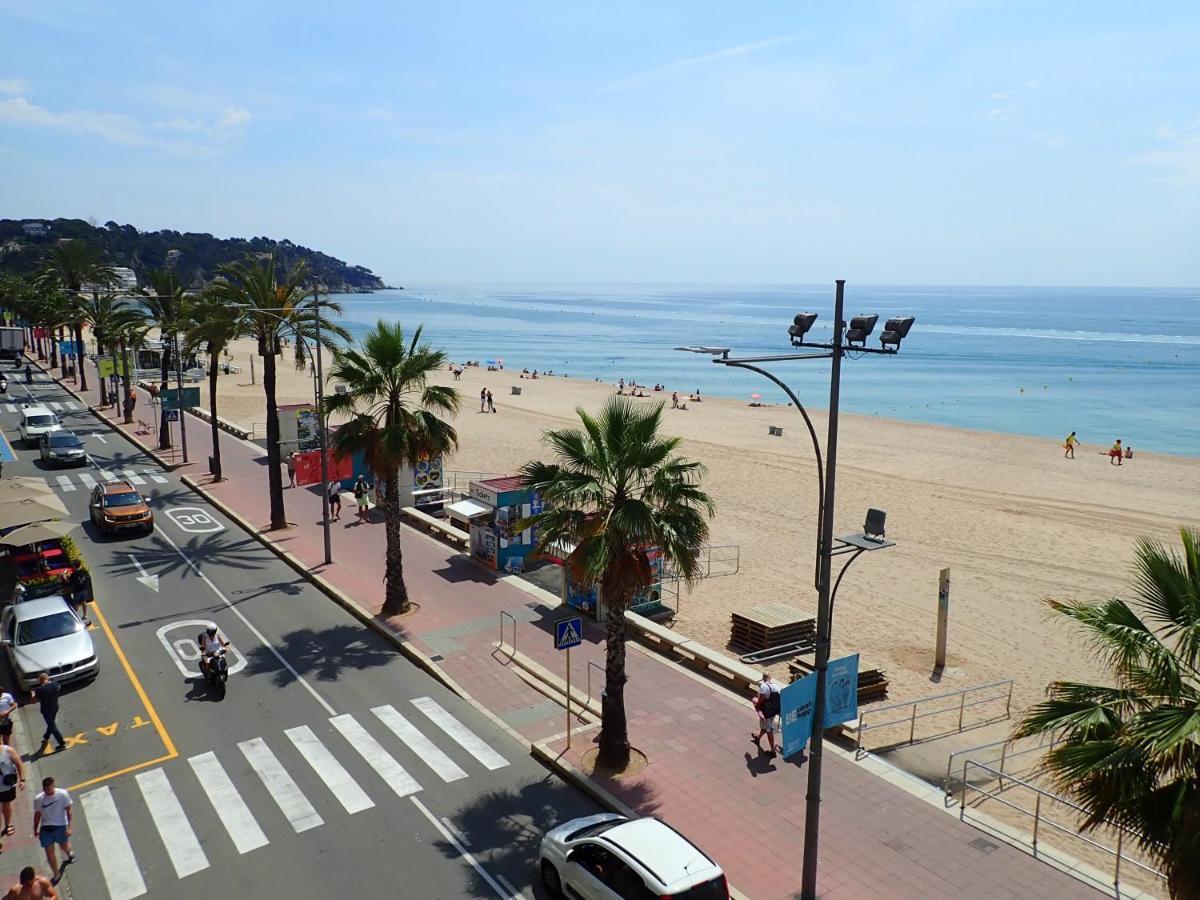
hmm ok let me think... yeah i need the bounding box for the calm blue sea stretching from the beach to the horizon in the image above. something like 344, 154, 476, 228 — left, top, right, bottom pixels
328, 284, 1200, 456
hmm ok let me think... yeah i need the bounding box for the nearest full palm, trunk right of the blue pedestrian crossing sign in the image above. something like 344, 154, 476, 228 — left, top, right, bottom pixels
515, 397, 714, 769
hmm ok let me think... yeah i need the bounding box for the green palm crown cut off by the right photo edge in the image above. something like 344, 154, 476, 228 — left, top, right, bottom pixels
1015, 528, 1200, 899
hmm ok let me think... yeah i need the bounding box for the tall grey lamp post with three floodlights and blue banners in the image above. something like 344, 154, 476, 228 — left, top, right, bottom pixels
677, 278, 913, 900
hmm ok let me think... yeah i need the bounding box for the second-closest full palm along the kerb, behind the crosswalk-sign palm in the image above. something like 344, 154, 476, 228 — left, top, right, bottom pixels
325, 320, 462, 616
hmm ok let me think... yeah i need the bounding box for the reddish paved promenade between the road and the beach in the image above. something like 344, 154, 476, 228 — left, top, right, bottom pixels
79, 379, 1100, 900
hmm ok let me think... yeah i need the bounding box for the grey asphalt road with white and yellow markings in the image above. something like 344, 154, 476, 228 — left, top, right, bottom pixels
0, 367, 598, 900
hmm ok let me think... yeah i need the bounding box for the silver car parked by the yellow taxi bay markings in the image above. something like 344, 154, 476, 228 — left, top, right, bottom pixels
0, 594, 100, 689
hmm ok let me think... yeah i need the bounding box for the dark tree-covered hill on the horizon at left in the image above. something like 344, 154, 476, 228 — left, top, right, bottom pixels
0, 218, 386, 293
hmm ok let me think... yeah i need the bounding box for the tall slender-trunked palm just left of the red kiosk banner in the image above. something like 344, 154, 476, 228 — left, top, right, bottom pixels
210, 253, 346, 529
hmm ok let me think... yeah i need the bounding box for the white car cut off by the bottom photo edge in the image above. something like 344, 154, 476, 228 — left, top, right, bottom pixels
541, 812, 730, 900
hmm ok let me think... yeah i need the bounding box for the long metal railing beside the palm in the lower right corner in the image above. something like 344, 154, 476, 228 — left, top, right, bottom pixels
959, 760, 1165, 894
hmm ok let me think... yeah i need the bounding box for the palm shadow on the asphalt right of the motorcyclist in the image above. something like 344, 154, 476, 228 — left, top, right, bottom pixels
246, 624, 396, 688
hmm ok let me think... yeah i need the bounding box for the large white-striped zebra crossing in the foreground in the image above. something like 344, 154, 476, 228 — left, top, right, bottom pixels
79, 697, 509, 900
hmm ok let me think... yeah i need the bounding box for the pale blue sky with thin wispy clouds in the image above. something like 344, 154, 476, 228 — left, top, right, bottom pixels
0, 0, 1200, 287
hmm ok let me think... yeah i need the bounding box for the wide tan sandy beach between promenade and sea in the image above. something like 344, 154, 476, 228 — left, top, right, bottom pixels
202, 342, 1200, 708
